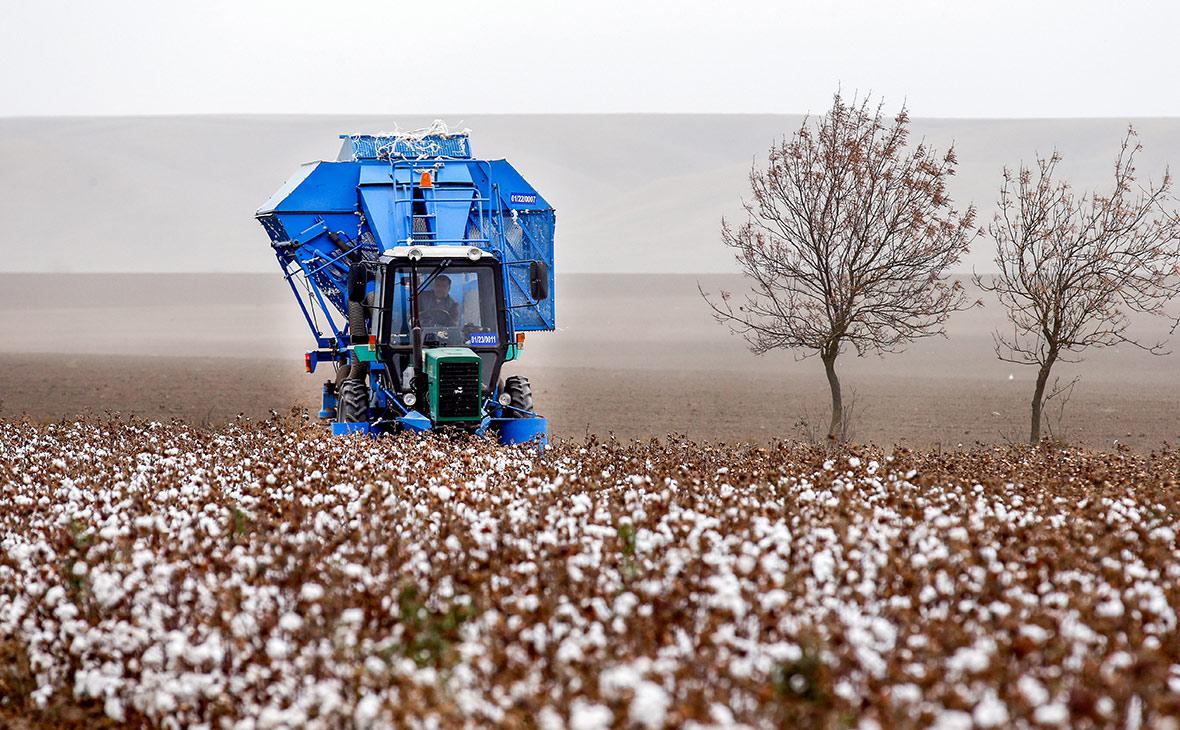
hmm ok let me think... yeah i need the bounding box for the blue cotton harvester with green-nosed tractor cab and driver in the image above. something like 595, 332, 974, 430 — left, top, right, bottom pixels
256, 124, 555, 443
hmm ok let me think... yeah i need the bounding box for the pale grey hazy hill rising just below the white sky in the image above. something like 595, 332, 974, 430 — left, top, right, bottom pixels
0, 114, 1180, 274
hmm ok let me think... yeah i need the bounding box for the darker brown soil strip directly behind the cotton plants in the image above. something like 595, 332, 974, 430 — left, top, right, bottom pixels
0, 355, 1180, 449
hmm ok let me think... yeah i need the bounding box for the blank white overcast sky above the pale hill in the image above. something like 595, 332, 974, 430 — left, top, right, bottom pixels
0, 0, 1180, 117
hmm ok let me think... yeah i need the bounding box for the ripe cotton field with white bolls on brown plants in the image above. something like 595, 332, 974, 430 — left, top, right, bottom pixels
0, 420, 1180, 730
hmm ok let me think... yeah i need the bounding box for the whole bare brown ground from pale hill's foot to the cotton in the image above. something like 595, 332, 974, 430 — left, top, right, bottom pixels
0, 275, 1180, 448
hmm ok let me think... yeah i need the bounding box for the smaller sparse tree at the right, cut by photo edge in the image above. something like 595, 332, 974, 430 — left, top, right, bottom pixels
975, 129, 1180, 443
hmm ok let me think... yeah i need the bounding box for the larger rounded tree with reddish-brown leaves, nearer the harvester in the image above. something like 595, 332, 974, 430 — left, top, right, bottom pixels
701, 93, 975, 440
